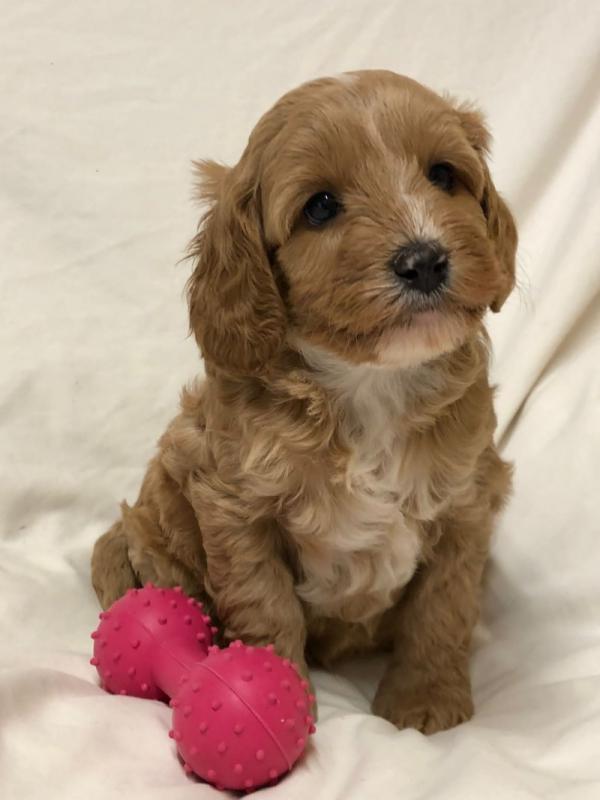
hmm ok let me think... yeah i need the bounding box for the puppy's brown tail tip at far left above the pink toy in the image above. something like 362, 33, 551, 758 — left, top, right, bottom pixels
92, 520, 139, 608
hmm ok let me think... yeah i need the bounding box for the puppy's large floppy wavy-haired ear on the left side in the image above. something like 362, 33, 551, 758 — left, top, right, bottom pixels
186, 160, 286, 374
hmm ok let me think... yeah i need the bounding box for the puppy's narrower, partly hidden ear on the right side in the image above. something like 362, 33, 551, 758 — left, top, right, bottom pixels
456, 104, 518, 311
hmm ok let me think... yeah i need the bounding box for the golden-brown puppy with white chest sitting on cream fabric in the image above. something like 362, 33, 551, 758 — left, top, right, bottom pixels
92, 71, 517, 733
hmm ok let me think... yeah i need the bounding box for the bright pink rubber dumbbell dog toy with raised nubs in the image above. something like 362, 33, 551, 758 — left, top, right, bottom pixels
91, 584, 315, 790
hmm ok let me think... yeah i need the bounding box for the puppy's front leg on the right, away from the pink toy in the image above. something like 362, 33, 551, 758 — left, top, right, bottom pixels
373, 509, 492, 734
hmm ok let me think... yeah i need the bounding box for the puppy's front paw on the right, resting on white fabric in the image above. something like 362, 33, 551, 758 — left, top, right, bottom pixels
373, 668, 473, 735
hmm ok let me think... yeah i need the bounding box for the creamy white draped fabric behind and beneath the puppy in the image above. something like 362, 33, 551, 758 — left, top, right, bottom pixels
0, 0, 600, 800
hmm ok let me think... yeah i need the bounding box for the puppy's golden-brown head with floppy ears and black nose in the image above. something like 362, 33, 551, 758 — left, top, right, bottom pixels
188, 71, 517, 373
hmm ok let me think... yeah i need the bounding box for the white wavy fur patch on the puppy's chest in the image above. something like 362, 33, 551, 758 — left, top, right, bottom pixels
287, 350, 432, 623
